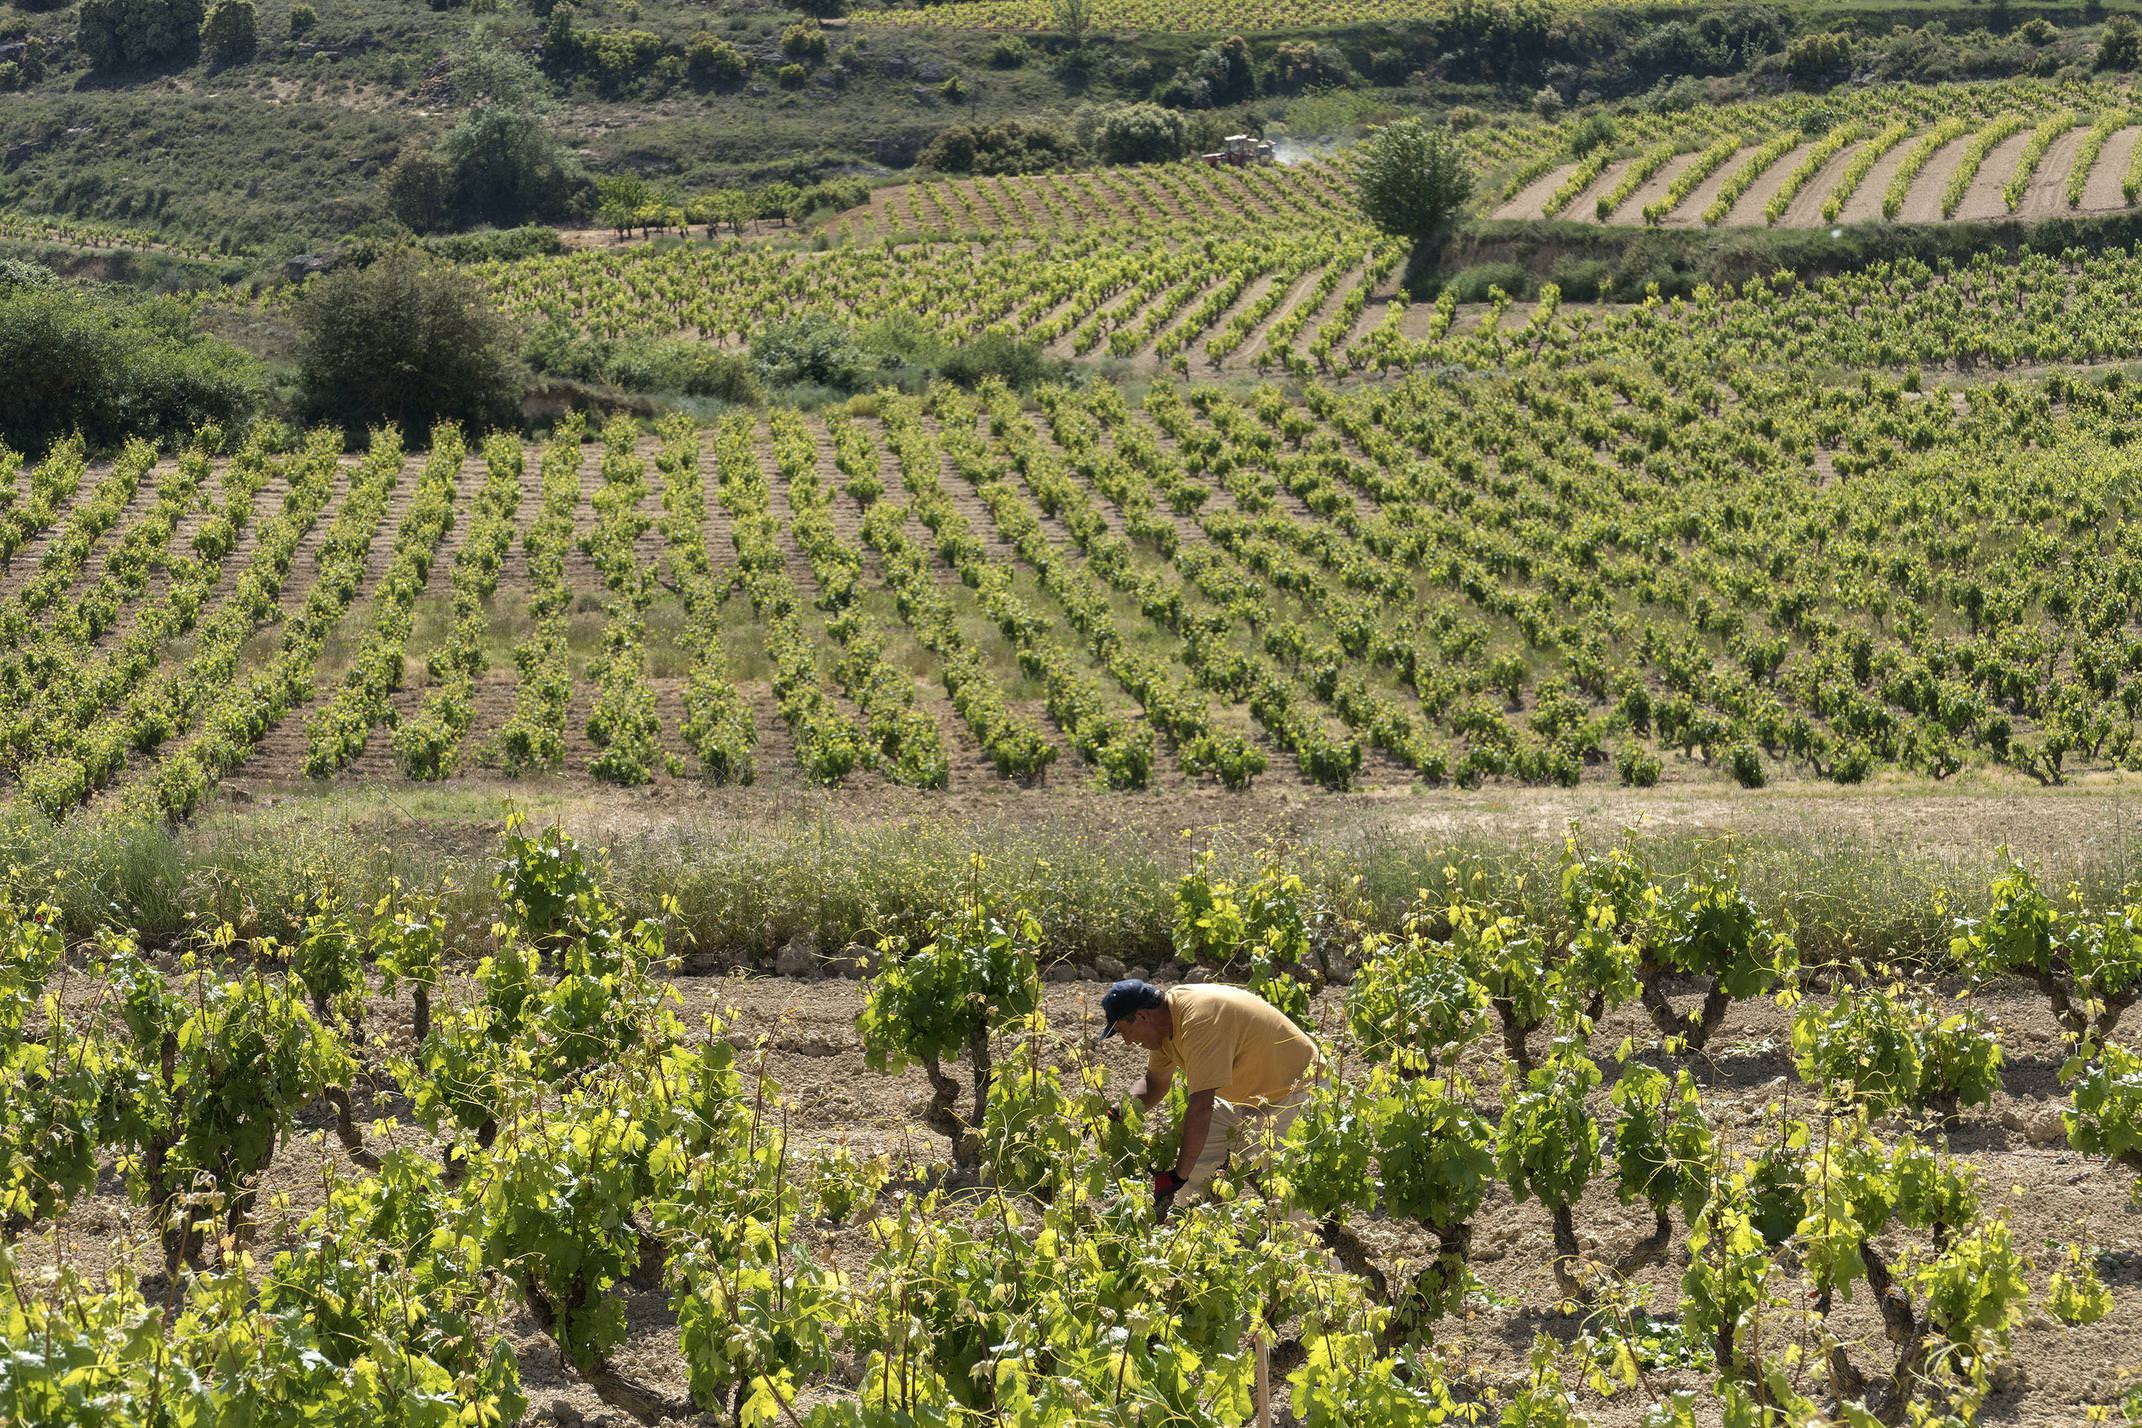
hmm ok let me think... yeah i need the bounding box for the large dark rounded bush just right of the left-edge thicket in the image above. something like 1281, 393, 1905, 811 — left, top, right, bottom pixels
298, 250, 521, 430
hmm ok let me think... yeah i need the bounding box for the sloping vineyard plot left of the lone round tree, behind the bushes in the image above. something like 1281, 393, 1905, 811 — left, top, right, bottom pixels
478, 165, 1403, 375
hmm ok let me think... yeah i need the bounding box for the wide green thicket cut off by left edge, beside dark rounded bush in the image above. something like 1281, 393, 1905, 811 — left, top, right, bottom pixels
0, 282, 266, 450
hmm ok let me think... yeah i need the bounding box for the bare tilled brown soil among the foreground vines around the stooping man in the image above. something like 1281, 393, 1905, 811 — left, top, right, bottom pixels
19, 968, 2142, 1428
